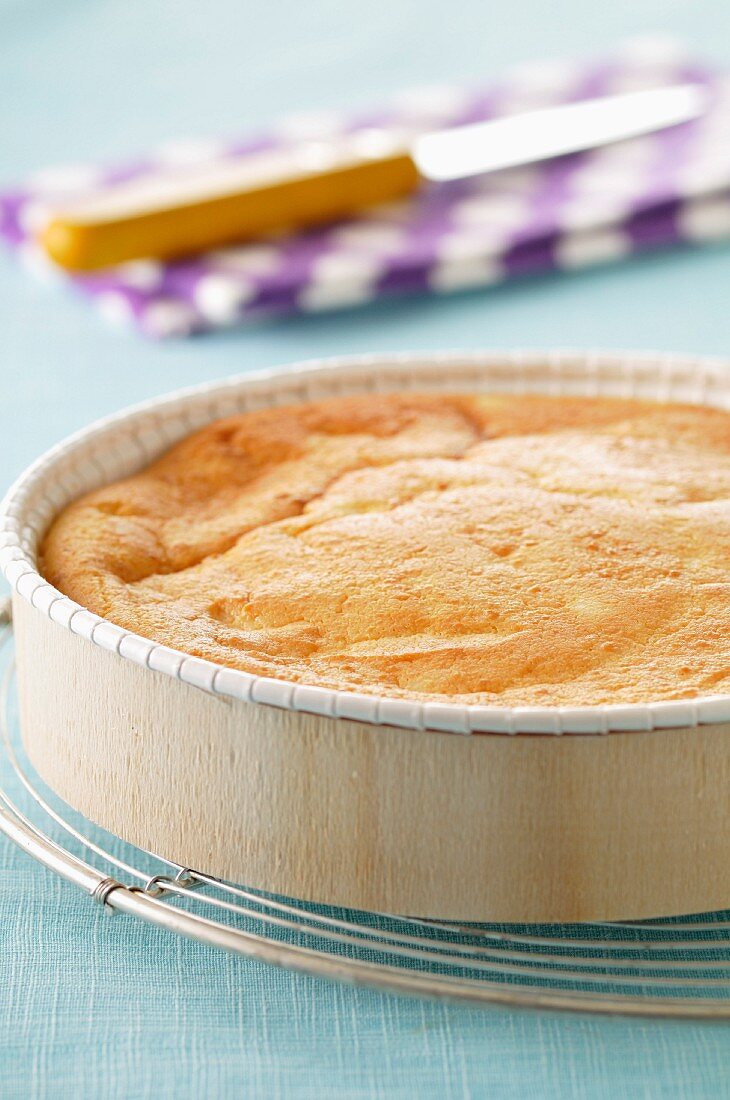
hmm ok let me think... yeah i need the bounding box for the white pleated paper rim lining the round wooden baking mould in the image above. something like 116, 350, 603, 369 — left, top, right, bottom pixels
0, 351, 730, 735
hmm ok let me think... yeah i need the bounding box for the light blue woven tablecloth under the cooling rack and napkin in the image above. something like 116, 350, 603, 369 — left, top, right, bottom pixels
0, 0, 730, 1100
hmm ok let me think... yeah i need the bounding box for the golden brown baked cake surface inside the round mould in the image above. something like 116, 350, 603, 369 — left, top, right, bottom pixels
43, 393, 730, 706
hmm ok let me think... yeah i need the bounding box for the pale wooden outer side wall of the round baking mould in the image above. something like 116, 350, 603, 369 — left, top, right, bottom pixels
14, 597, 730, 921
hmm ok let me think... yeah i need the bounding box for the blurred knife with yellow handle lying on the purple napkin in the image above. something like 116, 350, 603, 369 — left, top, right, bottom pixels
38, 84, 707, 272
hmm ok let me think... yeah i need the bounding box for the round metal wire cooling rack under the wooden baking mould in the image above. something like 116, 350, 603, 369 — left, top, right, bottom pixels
0, 602, 730, 1019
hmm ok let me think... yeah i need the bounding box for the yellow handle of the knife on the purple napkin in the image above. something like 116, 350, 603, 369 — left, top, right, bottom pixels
40, 149, 420, 272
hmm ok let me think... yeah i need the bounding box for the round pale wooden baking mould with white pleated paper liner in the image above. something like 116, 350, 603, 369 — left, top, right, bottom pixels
0, 352, 730, 922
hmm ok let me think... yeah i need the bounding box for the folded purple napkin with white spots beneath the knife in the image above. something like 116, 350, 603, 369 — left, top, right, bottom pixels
0, 42, 730, 337
